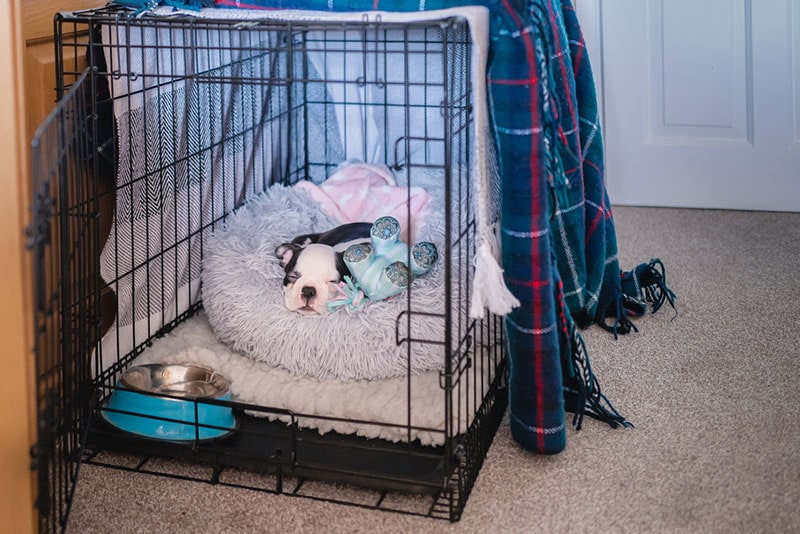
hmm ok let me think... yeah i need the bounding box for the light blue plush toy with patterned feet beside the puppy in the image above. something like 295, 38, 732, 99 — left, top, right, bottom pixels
328, 216, 439, 309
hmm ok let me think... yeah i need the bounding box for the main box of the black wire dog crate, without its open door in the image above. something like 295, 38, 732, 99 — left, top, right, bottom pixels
34, 7, 507, 521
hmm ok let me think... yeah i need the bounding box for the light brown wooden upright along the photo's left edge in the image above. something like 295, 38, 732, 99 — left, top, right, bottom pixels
0, 0, 38, 534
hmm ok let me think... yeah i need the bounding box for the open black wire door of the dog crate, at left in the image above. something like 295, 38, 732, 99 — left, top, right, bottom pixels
27, 74, 99, 532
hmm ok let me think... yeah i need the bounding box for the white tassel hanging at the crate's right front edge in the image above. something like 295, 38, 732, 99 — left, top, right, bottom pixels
469, 241, 519, 319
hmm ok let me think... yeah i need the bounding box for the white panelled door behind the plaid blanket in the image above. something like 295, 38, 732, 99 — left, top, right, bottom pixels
577, 0, 800, 211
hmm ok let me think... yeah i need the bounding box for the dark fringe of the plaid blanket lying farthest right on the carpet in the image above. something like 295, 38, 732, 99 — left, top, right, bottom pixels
621, 258, 678, 319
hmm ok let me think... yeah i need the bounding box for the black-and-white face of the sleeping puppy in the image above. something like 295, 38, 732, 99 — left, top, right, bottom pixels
275, 243, 346, 315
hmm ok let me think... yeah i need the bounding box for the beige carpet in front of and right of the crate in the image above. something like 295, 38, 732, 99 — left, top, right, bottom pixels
69, 208, 800, 534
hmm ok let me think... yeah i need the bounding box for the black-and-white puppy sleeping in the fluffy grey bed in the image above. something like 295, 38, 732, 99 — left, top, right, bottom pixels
275, 222, 372, 315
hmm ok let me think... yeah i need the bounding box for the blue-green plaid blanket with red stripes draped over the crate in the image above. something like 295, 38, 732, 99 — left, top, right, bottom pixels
119, 0, 630, 453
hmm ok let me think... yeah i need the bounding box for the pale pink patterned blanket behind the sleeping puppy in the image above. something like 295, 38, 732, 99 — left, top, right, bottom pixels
295, 163, 431, 243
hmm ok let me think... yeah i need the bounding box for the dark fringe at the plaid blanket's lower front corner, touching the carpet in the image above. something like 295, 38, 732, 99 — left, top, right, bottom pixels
570, 325, 633, 430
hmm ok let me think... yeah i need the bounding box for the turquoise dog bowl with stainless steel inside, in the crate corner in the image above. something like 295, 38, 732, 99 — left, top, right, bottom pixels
102, 364, 236, 441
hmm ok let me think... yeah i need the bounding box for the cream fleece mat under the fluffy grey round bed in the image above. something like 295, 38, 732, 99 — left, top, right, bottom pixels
134, 313, 494, 445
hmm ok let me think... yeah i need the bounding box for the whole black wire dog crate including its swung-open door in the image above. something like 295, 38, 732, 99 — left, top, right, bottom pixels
29, 7, 507, 531
